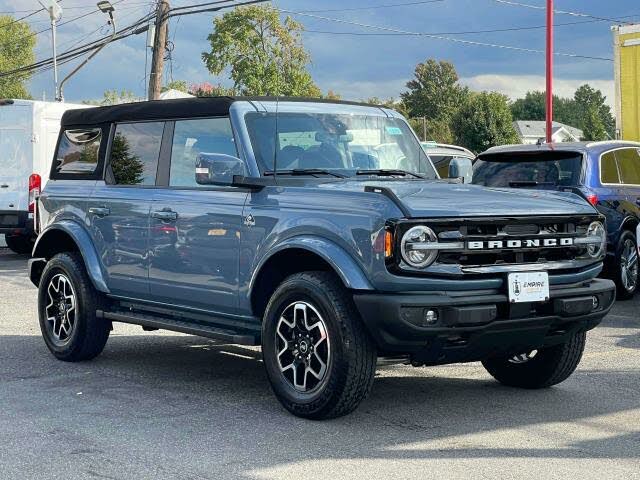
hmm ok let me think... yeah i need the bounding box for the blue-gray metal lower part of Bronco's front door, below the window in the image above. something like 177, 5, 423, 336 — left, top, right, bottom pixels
149, 188, 248, 313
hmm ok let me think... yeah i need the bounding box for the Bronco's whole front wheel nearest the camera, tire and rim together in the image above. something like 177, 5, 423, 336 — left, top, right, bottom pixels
262, 272, 376, 420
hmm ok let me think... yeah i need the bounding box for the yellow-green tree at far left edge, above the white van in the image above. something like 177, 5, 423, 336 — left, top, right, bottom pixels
0, 15, 36, 98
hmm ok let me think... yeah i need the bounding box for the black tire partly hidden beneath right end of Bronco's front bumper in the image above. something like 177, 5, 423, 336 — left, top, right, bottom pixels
482, 332, 587, 389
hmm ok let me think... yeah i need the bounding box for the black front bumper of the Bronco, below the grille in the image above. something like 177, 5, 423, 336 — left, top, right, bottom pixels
353, 279, 615, 365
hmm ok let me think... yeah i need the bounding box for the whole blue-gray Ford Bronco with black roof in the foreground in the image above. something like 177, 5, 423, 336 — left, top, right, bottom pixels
29, 97, 615, 419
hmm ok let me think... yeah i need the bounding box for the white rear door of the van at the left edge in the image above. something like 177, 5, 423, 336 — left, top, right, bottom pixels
0, 105, 33, 213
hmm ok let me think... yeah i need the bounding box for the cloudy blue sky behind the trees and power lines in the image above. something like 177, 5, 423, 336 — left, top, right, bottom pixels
0, 0, 640, 105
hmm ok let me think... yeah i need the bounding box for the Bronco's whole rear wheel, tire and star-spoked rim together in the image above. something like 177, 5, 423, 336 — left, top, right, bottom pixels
38, 253, 111, 362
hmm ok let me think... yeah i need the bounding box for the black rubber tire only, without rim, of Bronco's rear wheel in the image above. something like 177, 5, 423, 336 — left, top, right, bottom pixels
38, 252, 111, 362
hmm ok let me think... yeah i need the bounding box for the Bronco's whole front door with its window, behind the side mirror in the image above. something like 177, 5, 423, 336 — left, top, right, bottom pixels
149, 118, 248, 313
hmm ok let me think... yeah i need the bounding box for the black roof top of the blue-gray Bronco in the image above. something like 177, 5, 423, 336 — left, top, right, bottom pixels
61, 97, 376, 128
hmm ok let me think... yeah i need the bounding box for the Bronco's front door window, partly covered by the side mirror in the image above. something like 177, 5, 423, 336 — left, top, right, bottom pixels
169, 118, 238, 187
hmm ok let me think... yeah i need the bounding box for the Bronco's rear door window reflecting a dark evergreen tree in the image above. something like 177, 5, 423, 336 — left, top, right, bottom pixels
106, 122, 164, 185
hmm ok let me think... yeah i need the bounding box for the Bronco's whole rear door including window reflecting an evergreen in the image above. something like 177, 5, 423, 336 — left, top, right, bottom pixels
88, 122, 164, 299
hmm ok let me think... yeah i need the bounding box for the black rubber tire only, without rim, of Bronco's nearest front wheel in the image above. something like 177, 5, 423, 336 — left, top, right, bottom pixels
262, 272, 377, 420
